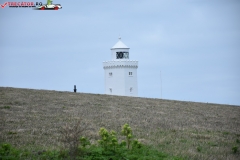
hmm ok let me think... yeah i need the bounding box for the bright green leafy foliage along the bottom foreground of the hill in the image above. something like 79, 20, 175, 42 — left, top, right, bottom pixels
0, 124, 183, 160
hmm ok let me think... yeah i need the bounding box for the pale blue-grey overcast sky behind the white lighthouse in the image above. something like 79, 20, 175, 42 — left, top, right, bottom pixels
0, 0, 240, 105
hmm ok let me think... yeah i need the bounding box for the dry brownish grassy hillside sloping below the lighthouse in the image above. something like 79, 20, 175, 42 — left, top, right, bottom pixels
0, 87, 240, 160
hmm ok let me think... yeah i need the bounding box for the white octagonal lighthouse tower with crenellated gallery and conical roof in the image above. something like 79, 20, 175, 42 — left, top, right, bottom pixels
103, 38, 138, 96
